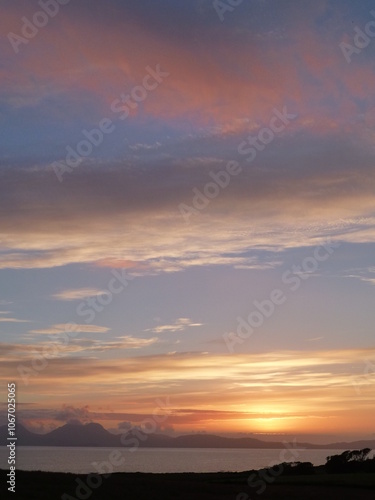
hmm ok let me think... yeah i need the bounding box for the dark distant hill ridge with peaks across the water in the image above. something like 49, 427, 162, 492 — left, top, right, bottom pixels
0, 423, 375, 450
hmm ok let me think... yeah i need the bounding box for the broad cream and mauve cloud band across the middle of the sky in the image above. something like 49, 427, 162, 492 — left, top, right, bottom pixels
0, 161, 375, 274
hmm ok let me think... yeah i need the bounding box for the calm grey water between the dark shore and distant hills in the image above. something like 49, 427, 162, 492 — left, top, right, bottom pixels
0, 446, 342, 474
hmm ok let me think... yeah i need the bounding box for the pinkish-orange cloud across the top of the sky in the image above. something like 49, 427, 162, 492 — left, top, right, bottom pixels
1, 1, 375, 132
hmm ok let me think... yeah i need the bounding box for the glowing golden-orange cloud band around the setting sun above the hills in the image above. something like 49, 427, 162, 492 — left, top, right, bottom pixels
0, 348, 375, 433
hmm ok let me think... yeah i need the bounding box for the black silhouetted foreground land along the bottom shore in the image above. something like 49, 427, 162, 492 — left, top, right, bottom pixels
0, 470, 375, 500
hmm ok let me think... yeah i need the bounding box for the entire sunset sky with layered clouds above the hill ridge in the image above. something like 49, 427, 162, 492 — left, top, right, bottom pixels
0, 0, 375, 442
